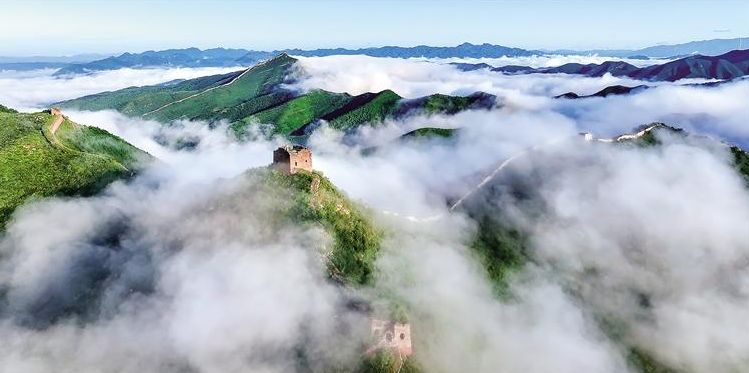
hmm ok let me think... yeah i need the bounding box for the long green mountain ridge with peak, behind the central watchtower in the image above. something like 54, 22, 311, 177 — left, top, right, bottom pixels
58, 54, 495, 137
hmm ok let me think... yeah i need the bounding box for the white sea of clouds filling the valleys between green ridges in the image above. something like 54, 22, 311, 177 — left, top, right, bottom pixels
0, 56, 749, 373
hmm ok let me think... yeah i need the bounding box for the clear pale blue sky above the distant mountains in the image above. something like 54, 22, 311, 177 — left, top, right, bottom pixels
0, 0, 749, 55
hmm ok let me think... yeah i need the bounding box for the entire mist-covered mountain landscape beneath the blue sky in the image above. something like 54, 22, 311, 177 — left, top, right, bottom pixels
0, 24, 749, 373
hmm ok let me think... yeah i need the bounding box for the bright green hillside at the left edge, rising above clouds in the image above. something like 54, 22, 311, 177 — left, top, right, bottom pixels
0, 109, 150, 230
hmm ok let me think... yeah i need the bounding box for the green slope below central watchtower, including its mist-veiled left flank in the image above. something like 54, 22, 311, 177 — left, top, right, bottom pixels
232, 168, 383, 285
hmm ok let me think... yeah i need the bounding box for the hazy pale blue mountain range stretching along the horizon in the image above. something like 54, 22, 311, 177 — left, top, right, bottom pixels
0, 38, 736, 76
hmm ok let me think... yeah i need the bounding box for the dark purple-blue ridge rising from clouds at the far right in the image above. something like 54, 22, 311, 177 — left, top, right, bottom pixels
453, 50, 749, 82
